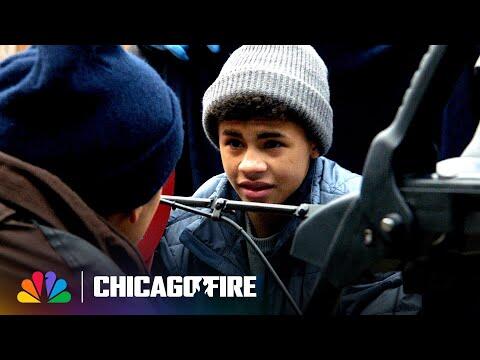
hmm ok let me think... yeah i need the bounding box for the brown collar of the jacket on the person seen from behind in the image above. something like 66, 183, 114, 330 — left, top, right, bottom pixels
0, 152, 147, 273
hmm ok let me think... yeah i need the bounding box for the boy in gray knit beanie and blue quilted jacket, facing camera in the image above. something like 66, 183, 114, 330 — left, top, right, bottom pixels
156, 45, 416, 314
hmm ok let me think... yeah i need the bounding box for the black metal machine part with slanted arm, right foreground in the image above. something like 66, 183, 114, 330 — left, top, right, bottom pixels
291, 45, 477, 314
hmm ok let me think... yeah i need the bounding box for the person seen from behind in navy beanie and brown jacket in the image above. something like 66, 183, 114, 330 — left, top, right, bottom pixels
0, 45, 183, 313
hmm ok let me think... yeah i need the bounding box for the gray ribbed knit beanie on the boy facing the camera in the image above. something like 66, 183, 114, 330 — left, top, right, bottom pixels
203, 45, 333, 155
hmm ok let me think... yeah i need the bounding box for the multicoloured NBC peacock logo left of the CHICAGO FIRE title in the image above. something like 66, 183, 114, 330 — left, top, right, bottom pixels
17, 271, 72, 304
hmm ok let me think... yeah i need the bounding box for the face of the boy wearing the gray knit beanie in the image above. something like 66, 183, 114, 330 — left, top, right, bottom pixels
218, 119, 319, 204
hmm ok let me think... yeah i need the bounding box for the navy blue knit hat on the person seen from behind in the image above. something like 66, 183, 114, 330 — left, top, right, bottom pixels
0, 45, 183, 214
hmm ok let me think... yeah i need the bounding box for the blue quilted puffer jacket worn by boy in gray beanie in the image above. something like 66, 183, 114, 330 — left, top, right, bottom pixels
153, 157, 420, 314
